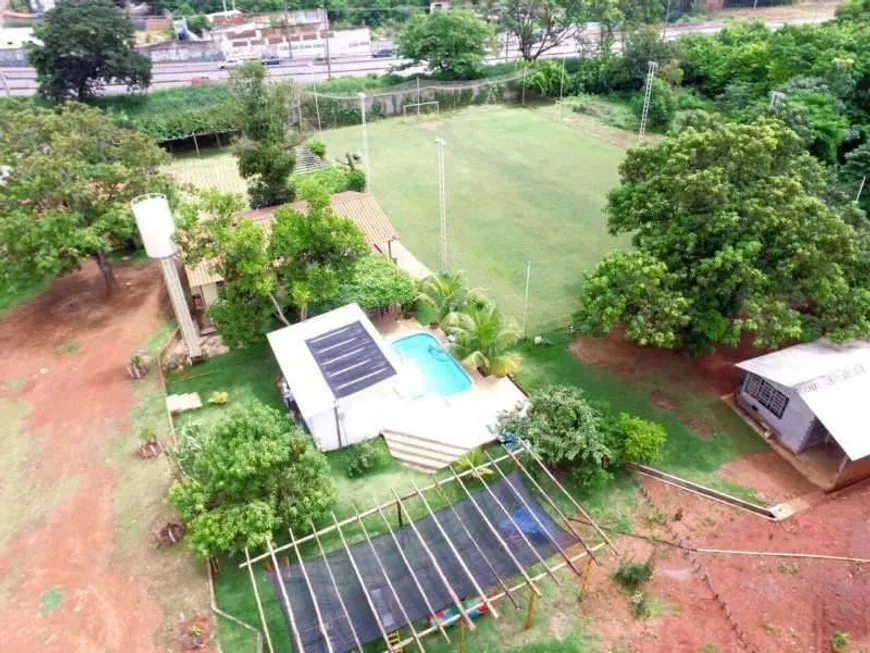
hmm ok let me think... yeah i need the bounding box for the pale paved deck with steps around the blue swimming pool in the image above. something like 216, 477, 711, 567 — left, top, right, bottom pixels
374, 318, 526, 470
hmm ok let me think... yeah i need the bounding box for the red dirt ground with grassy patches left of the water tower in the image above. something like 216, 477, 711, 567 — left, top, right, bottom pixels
0, 266, 209, 653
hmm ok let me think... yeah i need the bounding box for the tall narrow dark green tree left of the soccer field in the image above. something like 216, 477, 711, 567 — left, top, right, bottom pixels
230, 62, 301, 208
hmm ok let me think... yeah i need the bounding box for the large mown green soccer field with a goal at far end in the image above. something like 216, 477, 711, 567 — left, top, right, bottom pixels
172, 106, 627, 330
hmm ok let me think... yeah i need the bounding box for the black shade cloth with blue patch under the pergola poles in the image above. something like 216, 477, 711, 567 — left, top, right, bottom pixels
269, 472, 578, 653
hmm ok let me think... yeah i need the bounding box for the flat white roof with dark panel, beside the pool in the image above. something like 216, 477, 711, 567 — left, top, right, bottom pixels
267, 304, 399, 418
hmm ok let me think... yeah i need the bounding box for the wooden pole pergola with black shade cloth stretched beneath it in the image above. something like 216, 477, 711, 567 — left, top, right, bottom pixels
240, 445, 619, 653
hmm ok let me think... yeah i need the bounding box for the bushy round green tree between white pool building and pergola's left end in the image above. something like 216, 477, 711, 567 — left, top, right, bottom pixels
169, 402, 336, 558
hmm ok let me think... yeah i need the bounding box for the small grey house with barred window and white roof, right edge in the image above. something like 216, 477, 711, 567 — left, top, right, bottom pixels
737, 339, 870, 489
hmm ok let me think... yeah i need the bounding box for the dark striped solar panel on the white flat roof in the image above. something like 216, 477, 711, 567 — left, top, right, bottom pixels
305, 322, 396, 399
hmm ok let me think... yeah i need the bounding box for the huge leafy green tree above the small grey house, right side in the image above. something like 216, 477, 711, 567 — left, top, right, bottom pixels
577, 120, 870, 350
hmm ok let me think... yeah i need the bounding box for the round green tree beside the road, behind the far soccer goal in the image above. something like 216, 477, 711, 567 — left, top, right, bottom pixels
397, 9, 494, 79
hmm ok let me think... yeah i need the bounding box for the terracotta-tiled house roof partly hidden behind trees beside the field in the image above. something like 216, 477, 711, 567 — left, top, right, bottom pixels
184, 191, 399, 288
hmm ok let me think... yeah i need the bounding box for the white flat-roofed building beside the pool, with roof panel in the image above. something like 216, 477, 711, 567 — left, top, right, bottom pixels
268, 304, 401, 451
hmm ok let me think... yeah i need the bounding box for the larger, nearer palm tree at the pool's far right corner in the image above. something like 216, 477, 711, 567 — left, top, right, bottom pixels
445, 303, 521, 376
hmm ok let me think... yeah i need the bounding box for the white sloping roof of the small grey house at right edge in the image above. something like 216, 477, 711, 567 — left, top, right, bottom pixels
737, 339, 870, 460
